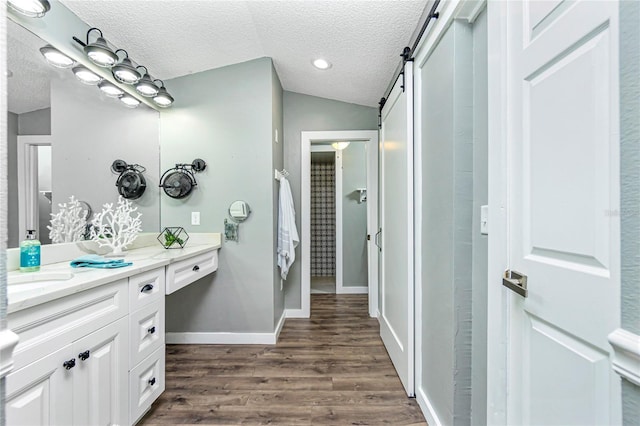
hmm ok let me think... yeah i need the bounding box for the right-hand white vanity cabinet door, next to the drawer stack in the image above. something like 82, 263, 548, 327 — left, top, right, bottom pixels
73, 317, 129, 425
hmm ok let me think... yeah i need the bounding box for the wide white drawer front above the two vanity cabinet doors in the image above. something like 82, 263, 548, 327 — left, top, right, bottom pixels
7, 278, 129, 370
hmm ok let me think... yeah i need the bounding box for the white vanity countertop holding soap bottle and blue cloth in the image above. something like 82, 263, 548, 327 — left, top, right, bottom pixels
7, 238, 221, 314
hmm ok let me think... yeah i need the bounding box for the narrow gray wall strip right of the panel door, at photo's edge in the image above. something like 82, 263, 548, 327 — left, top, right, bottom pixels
620, 1, 640, 425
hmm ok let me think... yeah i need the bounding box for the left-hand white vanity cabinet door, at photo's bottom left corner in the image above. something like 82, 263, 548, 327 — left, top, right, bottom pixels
5, 345, 77, 426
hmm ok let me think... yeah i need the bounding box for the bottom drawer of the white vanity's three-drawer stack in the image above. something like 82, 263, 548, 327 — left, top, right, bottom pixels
129, 345, 164, 424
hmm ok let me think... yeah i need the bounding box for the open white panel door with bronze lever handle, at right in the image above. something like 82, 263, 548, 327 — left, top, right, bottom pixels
505, 0, 620, 425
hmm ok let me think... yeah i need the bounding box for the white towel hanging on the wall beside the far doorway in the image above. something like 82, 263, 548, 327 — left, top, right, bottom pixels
278, 177, 300, 280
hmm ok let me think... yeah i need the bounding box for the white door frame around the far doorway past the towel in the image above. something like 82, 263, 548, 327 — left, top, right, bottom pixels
302, 130, 378, 318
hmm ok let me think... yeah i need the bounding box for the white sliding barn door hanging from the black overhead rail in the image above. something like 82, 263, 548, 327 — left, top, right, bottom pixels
379, 63, 414, 396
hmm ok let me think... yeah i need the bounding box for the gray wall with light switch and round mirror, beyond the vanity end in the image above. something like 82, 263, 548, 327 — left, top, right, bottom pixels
160, 58, 281, 333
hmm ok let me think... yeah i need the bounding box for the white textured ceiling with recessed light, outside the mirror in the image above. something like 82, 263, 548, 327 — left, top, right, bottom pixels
62, 0, 426, 106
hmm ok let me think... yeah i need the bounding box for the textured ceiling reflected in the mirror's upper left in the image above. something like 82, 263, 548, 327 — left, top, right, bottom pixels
7, 20, 55, 114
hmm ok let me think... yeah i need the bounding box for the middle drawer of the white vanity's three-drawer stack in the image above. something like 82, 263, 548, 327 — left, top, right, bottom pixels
129, 298, 164, 367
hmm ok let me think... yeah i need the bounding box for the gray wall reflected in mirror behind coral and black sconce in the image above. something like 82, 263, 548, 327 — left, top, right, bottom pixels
51, 73, 159, 232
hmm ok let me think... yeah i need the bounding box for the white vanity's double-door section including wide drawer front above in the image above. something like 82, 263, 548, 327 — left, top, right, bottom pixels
6, 279, 129, 425
